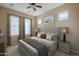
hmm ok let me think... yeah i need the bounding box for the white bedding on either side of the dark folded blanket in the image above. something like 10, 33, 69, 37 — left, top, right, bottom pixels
19, 37, 57, 55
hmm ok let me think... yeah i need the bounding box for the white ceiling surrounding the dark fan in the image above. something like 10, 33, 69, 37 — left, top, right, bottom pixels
0, 3, 63, 16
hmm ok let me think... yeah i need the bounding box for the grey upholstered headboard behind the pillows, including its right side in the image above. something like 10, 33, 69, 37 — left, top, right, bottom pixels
39, 27, 60, 41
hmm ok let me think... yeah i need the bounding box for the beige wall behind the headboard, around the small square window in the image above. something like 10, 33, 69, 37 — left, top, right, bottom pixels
37, 4, 79, 53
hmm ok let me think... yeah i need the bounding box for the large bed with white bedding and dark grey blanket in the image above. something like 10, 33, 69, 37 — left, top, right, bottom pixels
18, 27, 59, 56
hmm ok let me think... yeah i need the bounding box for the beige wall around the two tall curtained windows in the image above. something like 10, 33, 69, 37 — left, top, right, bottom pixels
0, 7, 35, 45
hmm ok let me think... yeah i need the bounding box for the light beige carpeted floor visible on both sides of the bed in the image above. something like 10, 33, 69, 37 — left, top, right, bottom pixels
6, 45, 78, 56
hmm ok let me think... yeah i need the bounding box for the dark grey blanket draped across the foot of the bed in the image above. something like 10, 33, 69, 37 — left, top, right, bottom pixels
23, 39, 48, 56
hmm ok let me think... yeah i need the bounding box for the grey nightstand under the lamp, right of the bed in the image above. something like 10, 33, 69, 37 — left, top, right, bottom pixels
58, 41, 71, 53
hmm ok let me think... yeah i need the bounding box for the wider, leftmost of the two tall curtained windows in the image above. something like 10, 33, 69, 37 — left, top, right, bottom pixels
9, 15, 19, 36
